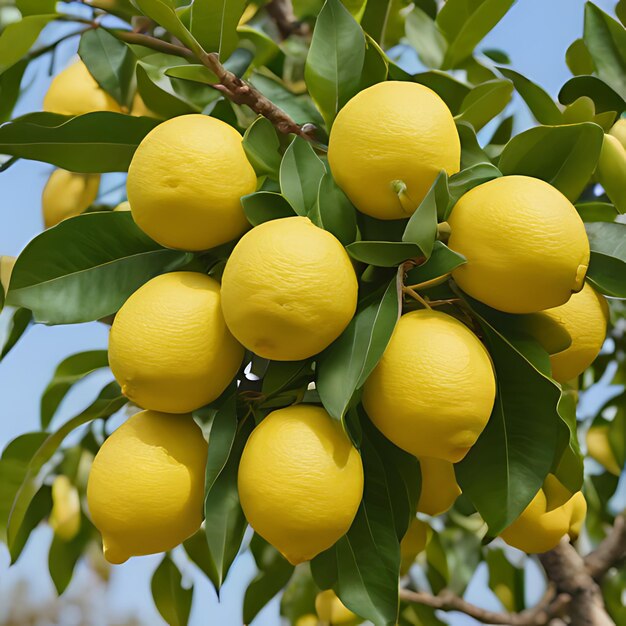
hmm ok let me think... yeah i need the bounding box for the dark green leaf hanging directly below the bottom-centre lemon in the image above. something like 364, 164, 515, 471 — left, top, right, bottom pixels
243, 534, 294, 624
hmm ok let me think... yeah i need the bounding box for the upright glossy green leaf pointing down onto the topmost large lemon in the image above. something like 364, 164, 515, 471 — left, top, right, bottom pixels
304, 0, 365, 129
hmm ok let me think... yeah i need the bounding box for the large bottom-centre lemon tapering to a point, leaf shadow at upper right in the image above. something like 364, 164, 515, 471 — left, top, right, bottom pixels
239, 404, 363, 565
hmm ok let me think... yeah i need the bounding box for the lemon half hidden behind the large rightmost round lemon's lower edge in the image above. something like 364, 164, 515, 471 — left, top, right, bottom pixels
537, 283, 609, 383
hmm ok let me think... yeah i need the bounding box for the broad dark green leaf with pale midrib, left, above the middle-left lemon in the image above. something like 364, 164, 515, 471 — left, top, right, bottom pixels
7, 211, 192, 324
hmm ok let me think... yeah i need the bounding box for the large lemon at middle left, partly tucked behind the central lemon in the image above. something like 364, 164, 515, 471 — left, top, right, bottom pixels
109, 272, 243, 413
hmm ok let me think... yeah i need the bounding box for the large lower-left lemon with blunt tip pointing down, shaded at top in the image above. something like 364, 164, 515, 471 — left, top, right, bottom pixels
87, 411, 207, 564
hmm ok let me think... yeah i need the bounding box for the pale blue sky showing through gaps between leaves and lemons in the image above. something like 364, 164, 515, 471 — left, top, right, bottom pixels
0, 0, 615, 626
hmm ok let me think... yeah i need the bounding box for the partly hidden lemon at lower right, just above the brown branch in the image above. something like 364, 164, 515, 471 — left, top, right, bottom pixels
500, 474, 586, 554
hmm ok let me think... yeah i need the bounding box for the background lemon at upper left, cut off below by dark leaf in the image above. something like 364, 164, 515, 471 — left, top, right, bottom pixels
43, 61, 121, 115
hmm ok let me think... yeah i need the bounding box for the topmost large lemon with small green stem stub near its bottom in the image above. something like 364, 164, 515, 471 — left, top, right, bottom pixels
328, 81, 461, 220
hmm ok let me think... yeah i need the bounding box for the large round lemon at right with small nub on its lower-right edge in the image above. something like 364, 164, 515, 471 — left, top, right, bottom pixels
448, 176, 589, 313
